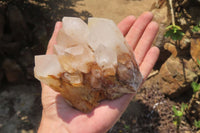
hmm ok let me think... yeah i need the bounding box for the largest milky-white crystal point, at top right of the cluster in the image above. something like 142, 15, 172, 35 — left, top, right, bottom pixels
88, 18, 128, 53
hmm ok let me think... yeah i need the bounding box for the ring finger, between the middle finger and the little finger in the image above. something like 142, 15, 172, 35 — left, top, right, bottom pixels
134, 22, 159, 65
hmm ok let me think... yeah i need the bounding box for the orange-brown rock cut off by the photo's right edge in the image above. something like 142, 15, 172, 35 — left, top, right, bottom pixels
190, 38, 200, 62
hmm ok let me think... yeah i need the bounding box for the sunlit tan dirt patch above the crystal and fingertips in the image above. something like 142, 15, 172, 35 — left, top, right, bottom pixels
74, 0, 156, 23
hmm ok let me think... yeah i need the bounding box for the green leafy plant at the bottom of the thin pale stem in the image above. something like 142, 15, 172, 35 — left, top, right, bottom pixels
165, 25, 185, 41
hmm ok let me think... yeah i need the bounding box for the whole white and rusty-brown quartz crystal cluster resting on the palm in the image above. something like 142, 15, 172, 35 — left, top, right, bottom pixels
34, 17, 143, 112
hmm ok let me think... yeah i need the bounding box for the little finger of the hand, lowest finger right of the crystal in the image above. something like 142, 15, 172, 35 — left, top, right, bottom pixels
140, 47, 160, 79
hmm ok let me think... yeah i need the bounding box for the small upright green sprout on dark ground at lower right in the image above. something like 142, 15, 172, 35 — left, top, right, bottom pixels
172, 103, 188, 131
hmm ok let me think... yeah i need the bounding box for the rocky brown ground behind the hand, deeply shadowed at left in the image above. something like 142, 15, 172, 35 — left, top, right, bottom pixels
0, 0, 200, 133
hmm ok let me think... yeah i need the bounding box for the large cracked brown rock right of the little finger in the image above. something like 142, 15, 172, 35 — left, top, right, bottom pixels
159, 56, 198, 98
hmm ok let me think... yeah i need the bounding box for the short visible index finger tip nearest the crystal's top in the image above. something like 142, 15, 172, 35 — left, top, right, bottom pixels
117, 16, 136, 36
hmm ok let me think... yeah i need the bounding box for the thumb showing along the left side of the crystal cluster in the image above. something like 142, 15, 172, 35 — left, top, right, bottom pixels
46, 22, 62, 54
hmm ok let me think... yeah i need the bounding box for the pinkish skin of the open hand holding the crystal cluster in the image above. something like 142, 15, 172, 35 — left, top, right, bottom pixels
38, 12, 159, 133
